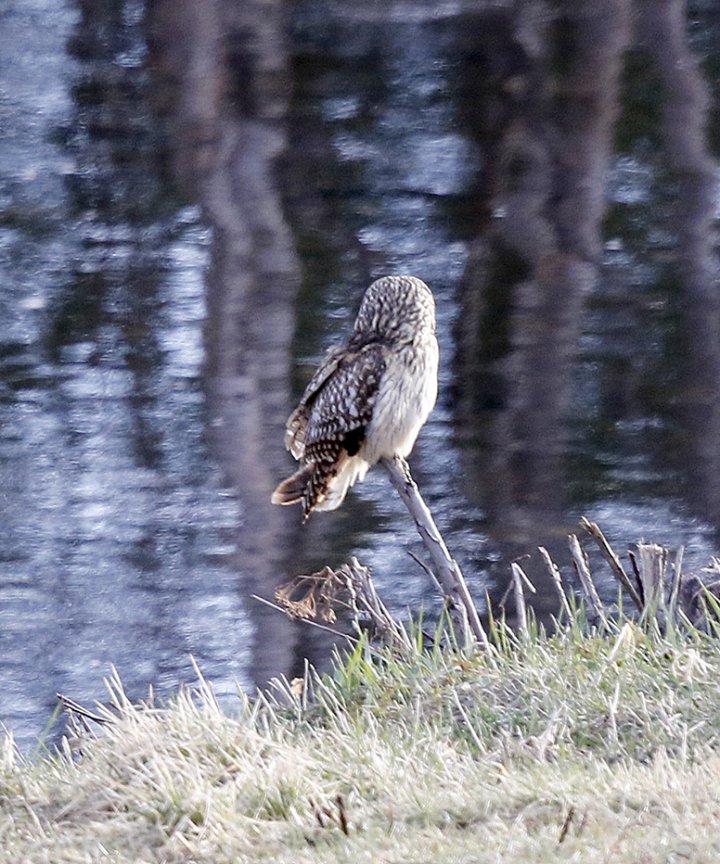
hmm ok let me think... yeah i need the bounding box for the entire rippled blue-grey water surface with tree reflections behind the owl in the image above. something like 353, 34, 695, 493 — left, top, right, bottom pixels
0, 0, 720, 741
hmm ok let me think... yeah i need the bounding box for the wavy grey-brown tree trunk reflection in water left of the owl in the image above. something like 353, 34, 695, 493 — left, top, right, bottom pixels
148, 0, 344, 686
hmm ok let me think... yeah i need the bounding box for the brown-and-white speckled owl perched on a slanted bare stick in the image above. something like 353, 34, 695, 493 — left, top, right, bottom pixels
272, 276, 438, 518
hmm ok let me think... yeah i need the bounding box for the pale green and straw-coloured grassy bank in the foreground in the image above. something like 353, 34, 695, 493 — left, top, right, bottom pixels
0, 623, 720, 864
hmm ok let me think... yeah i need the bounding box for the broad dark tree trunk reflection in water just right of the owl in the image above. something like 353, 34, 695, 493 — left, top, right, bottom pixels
456, 0, 631, 603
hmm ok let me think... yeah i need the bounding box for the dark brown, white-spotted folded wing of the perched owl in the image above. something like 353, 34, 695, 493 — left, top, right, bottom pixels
285, 343, 385, 462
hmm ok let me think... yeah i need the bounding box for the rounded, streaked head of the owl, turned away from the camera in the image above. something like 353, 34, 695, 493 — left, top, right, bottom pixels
354, 276, 435, 344
